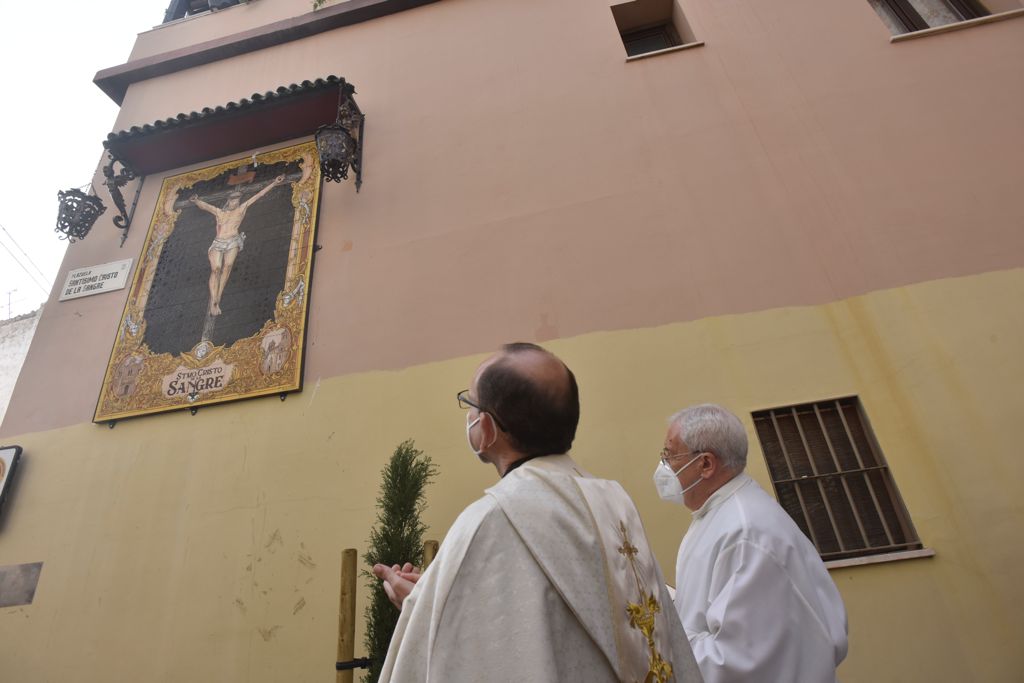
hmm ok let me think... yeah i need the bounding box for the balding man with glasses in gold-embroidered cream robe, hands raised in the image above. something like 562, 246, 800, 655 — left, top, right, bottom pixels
374, 343, 700, 683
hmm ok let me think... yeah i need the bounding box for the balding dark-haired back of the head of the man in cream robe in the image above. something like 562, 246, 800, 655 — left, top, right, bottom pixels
476, 342, 580, 456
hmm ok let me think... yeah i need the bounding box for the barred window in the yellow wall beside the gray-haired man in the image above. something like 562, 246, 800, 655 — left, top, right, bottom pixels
754, 396, 922, 560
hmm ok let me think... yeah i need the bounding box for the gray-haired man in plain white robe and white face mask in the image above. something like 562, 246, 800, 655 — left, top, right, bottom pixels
654, 404, 847, 683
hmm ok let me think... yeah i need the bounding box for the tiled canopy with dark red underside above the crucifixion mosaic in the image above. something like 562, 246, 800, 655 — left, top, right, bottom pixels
103, 76, 354, 175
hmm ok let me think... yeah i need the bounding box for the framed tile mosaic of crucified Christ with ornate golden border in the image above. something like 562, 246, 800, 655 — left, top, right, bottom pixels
94, 142, 319, 422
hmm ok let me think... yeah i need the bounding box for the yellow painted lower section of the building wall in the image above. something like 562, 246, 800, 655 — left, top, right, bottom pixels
0, 269, 1024, 682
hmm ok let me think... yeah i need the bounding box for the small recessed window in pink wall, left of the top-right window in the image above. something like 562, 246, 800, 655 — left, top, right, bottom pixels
611, 0, 695, 57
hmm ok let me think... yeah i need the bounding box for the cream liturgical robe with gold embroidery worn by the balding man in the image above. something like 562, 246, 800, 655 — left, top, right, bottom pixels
380, 456, 700, 683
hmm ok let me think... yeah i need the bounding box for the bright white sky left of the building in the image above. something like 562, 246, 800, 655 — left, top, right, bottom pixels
0, 0, 170, 319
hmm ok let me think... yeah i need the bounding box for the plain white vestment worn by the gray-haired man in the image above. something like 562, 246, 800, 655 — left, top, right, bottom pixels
675, 473, 847, 683
